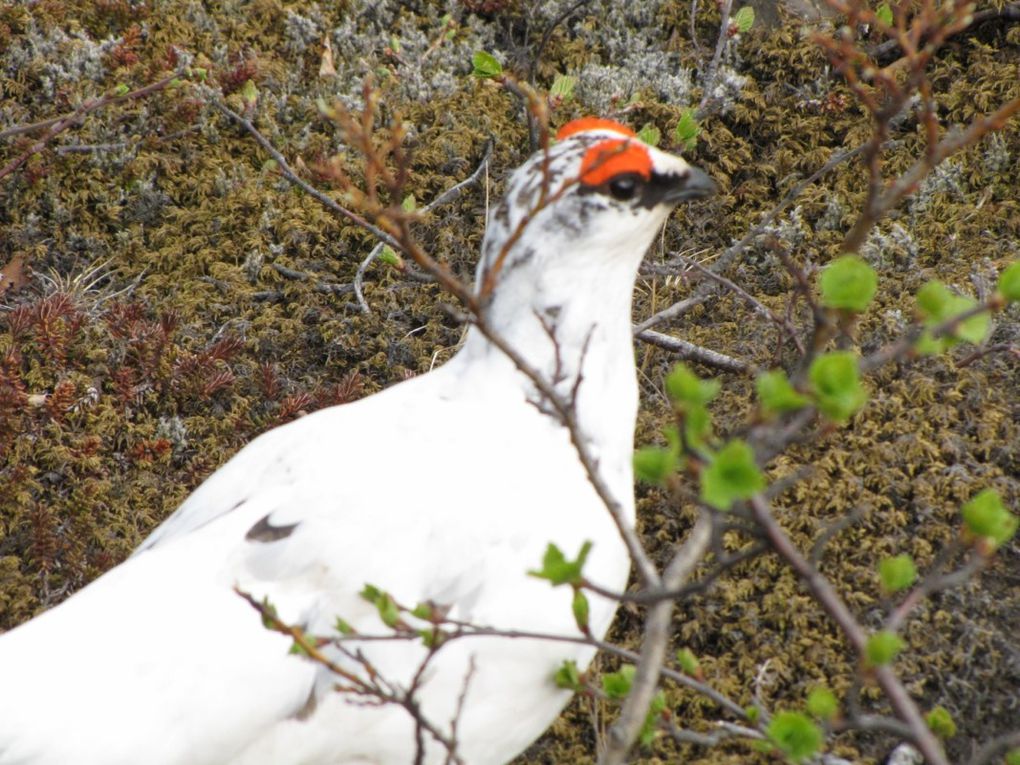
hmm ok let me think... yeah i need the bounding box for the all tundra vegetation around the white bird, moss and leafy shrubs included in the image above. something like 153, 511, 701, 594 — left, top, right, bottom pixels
0, 0, 1020, 765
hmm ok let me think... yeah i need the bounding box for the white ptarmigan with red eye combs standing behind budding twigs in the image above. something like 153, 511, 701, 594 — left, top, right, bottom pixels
0, 118, 713, 765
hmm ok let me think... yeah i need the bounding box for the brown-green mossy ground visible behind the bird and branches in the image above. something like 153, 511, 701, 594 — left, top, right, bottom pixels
0, 0, 1020, 763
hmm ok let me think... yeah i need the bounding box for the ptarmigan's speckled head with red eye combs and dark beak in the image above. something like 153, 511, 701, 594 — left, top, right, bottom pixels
477, 117, 715, 302
